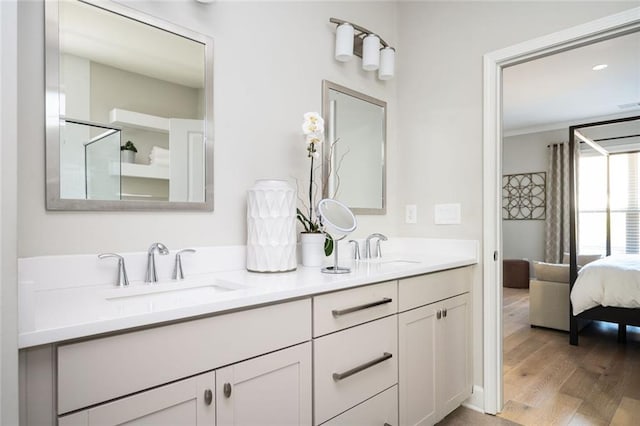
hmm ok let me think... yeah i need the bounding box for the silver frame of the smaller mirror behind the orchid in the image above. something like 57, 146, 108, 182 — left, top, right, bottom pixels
322, 80, 387, 215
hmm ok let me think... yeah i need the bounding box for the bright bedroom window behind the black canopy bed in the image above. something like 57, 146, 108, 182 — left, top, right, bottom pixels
578, 153, 640, 254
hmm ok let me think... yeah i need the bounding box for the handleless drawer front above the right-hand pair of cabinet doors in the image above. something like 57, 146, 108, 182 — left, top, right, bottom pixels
398, 267, 471, 312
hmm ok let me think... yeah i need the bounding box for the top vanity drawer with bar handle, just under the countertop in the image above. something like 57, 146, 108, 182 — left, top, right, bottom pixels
313, 281, 398, 337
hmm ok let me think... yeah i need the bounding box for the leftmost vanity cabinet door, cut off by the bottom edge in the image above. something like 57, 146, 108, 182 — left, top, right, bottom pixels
58, 372, 215, 426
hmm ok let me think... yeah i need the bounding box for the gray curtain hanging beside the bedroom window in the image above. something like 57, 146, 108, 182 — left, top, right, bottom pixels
544, 142, 579, 263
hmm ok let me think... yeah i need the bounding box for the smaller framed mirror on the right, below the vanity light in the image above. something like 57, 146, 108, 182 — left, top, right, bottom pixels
322, 80, 387, 214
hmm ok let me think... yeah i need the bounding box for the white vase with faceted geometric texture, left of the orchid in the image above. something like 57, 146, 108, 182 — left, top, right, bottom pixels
247, 179, 297, 272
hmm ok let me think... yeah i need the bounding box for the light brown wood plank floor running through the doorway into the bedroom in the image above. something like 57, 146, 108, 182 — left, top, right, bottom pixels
441, 288, 640, 426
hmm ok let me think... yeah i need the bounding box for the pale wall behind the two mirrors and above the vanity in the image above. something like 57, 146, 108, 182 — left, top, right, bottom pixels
18, 0, 398, 256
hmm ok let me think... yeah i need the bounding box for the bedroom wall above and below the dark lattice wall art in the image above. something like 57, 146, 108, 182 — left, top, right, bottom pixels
502, 128, 569, 264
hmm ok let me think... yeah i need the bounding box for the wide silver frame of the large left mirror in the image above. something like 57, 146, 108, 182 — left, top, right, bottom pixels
44, 0, 214, 211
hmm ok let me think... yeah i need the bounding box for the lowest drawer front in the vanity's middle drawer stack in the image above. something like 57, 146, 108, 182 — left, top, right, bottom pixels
323, 385, 398, 426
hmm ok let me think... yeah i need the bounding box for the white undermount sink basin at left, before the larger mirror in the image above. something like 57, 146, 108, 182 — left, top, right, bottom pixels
103, 280, 242, 302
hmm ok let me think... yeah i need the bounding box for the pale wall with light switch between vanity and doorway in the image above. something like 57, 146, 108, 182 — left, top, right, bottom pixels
393, 1, 638, 394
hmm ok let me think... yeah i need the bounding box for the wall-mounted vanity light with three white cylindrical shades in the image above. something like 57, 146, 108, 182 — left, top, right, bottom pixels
329, 18, 396, 80
